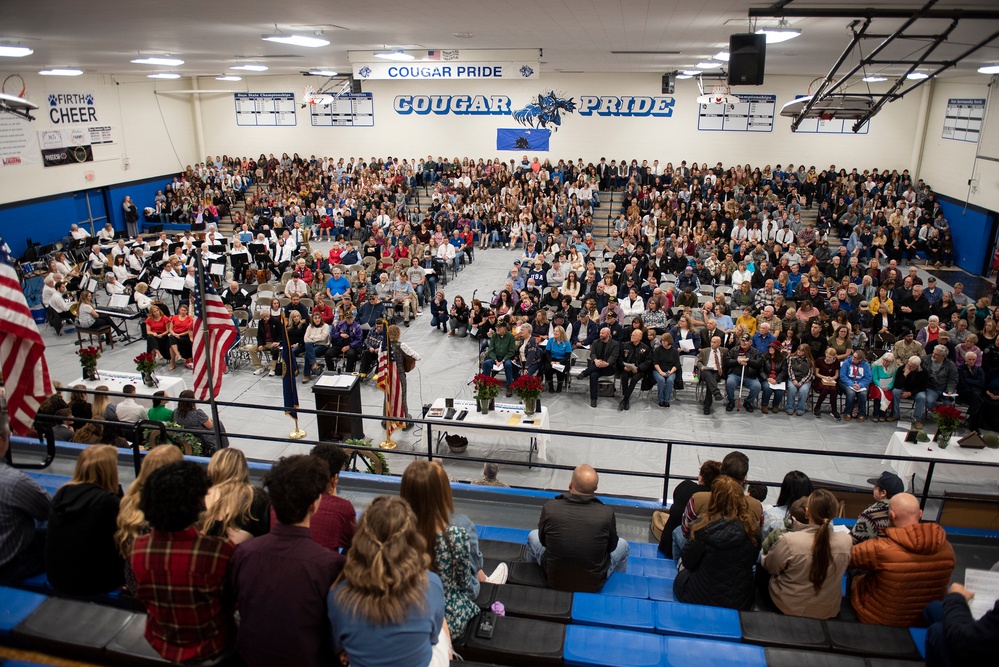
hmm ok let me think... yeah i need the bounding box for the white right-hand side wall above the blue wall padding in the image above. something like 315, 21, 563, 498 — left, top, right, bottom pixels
919, 76, 999, 211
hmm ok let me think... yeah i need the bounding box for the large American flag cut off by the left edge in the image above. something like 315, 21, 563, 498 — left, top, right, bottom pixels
0, 238, 52, 435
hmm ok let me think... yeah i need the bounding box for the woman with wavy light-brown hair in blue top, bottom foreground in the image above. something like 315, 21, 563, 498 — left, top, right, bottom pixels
326, 496, 451, 667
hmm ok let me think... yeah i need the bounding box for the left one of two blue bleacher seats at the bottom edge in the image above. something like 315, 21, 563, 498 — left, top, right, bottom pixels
564, 625, 663, 667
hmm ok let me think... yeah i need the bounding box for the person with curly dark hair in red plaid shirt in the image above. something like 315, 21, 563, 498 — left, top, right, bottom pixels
131, 461, 236, 662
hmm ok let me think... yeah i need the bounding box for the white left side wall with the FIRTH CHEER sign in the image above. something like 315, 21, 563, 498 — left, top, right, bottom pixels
0, 73, 196, 204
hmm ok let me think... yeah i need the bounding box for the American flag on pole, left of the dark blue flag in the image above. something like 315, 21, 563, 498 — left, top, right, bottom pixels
191, 263, 239, 401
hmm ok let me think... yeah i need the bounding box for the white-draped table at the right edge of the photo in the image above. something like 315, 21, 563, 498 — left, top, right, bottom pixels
882, 431, 999, 498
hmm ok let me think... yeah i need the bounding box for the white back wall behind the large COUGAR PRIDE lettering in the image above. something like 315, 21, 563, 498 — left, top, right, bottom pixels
201, 74, 919, 175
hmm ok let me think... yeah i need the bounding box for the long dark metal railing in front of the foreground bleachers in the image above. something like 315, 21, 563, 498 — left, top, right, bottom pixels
8, 391, 999, 507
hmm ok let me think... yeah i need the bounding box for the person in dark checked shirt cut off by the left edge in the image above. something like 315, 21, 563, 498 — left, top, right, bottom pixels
0, 398, 51, 584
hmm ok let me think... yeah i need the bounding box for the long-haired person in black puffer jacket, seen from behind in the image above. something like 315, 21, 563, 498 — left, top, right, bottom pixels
673, 475, 760, 610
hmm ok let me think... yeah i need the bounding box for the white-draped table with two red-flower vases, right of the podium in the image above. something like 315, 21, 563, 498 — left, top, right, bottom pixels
423, 398, 551, 462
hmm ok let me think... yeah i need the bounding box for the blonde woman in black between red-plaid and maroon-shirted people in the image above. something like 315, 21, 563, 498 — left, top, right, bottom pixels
198, 447, 271, 544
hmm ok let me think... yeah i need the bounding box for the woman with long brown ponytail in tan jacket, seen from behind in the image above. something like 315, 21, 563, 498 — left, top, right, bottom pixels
756, 489, 853, 619
